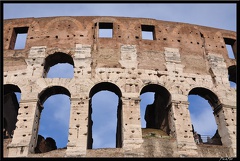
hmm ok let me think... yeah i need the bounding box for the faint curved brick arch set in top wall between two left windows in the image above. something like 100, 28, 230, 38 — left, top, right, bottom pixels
44, 17, 83, 30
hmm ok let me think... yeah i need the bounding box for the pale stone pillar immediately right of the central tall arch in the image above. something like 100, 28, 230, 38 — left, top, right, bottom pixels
122, 97, 143, 151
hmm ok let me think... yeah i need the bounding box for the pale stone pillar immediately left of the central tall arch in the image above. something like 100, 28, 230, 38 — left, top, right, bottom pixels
66, 98, 89, 157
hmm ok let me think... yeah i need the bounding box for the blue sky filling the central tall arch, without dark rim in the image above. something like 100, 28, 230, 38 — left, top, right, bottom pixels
92, 91, 118, 149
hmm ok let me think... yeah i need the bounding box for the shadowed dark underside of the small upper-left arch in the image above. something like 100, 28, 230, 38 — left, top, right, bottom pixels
43, 52, 74, 78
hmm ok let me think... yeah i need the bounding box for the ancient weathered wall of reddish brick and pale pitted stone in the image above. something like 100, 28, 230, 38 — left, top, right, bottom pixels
3, 16, 237, 157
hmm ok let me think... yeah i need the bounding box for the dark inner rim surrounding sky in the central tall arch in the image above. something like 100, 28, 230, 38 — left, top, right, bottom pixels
87, 82, 122, 149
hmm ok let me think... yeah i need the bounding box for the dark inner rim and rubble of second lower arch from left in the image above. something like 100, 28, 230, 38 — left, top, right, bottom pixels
34, 86, 71, 153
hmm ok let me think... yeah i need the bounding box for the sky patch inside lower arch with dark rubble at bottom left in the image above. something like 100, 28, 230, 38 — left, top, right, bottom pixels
38, 93, 70, 150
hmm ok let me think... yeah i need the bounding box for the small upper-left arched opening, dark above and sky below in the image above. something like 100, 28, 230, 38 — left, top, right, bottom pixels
43, 52, 74, 78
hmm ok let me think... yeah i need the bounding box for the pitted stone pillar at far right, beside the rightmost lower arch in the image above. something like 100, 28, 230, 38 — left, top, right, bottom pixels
214, 104, 237, 157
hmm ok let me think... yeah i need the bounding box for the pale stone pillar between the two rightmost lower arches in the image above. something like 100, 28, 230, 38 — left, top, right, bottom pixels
170, 100, 198, 156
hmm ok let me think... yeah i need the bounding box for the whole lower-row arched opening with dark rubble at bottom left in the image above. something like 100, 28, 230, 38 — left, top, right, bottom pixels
35, 86, 71, 153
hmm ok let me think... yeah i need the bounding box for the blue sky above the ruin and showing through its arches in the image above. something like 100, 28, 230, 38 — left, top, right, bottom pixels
3, 3, 236, 148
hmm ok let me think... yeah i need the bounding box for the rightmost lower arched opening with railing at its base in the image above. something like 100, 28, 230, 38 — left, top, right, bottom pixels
188, 87, 222, 145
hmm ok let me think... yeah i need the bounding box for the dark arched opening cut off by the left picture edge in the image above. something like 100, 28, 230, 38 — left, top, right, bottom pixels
3, 84, 21, 139
